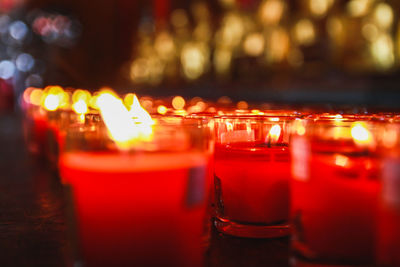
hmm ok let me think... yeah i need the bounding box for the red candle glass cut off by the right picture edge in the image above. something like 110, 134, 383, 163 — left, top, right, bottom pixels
377, 123, 400, 266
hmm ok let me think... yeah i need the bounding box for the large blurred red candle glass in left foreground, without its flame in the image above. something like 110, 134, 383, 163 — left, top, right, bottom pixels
59, 118, 209, 266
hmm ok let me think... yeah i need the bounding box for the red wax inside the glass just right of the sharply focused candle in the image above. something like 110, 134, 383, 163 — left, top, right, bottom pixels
291, 144, 380, 263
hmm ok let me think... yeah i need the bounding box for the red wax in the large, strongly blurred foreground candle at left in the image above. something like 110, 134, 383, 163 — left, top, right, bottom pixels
60, 152, 207, 266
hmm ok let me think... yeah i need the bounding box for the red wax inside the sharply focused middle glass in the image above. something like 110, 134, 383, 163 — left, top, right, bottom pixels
215, 142, 290, 224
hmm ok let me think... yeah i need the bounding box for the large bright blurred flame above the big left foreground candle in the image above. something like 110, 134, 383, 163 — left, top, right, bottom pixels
97, 92, 154, 150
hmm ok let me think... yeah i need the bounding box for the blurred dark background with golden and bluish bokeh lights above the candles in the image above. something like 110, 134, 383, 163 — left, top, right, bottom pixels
0, 0, 400, 110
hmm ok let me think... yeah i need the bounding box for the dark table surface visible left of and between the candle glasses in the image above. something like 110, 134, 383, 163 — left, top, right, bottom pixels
0, 114, 289, 267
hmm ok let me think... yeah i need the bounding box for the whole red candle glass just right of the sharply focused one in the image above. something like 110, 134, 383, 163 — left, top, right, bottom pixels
291, 118, 380, 265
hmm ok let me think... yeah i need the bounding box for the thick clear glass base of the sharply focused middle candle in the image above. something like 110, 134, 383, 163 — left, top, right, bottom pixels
214, 216, 291, 238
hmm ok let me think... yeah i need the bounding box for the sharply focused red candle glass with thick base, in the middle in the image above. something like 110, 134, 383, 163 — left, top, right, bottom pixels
214, 115, 293, 238
